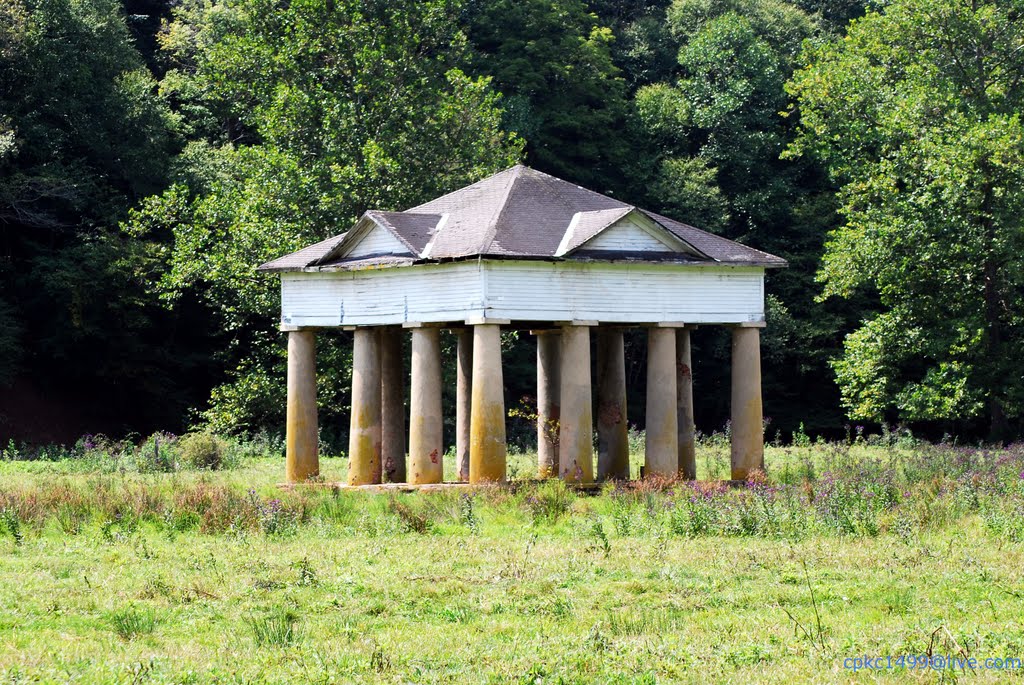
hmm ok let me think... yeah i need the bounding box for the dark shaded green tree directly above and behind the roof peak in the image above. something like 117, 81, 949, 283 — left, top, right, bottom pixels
465, 0, 630, 192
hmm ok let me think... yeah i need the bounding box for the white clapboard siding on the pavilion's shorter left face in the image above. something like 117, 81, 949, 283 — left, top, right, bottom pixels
281, 262, 483, 326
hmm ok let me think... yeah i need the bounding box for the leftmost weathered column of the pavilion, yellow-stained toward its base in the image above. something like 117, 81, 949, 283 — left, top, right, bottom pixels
285, 331, 319, 483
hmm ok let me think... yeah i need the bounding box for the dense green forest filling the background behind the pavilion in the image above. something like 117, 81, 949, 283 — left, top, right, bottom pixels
0, 0, 1024, 443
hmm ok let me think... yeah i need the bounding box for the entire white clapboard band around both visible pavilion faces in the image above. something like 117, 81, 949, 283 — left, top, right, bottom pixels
282, 260, 764, 327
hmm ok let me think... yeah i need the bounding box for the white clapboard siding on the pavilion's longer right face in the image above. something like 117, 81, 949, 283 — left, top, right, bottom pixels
484, 261, 764, 324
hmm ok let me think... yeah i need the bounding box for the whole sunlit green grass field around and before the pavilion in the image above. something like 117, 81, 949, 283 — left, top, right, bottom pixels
0, 442, 1024, 683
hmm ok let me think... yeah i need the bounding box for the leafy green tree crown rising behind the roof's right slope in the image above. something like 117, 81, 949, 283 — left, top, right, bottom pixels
636, 0, 813, 233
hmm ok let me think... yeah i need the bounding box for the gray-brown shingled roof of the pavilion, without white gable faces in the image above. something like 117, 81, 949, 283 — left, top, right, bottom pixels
259, 165, 786, 271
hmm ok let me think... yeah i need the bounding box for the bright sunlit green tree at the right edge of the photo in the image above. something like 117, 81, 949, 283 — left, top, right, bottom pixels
790, 0, 1024, 439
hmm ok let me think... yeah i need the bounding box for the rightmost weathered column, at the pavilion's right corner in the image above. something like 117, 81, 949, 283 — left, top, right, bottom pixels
732, 327, 765, 480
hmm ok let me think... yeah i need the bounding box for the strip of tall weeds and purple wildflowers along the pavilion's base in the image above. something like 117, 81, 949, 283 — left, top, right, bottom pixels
0, 440, 1024, 548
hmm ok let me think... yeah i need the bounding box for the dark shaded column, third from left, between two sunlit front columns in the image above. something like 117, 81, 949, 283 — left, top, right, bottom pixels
380, 326, 406, 483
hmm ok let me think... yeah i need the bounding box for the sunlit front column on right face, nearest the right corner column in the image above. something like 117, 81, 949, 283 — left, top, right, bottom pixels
644, 328, 679, 477
